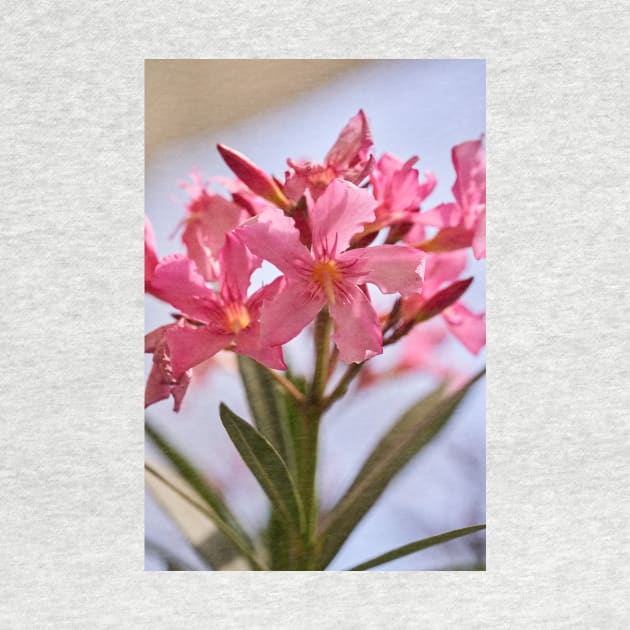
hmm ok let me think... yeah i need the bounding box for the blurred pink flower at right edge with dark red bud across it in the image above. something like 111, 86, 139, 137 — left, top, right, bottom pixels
402, 250, 486, 354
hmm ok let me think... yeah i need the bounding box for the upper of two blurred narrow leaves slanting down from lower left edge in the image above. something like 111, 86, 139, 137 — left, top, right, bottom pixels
144, 422, 264, 570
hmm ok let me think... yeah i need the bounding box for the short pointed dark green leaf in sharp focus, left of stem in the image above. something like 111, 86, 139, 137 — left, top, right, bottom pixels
219, 403, 304, 531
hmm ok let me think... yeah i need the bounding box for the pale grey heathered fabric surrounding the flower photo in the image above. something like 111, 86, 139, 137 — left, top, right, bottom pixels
0, 2, 630, 629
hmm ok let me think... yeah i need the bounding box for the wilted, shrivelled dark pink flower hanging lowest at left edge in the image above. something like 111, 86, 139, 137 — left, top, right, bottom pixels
144, 320, 192, 411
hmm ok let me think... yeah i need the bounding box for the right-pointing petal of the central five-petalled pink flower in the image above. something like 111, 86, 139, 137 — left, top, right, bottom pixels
338, 245, 426, 295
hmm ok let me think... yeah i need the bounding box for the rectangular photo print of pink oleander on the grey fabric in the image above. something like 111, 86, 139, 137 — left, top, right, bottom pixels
144, 59, 486, 571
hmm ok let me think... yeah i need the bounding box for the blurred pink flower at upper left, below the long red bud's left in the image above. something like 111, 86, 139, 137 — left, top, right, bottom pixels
182, 171, 248, 281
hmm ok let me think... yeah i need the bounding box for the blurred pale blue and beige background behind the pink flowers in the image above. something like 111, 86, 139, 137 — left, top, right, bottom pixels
145, 60, 486, 571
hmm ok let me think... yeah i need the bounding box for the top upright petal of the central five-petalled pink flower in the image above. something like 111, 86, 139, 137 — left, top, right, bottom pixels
311, 179, 377, 256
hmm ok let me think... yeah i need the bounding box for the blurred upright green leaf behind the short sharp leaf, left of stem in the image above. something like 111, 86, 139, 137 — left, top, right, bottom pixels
236, 354, 295, 470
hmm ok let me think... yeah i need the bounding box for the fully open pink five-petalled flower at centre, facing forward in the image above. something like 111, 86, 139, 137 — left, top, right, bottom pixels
236, 179, 424, 363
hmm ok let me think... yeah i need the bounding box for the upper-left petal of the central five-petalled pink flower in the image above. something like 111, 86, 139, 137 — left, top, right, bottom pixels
235, 208, 312, 276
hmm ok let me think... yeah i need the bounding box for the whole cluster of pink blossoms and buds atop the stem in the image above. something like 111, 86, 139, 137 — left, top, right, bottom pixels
145, 111, 485, 411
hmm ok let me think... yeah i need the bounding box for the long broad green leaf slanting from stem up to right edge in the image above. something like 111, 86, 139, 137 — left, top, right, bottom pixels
317, 369, 485, 570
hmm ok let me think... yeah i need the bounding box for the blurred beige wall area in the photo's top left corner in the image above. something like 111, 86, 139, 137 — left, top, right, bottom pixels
145, 59, 365, 161
